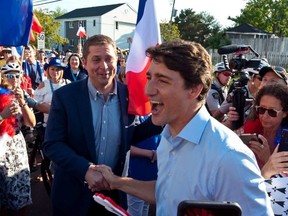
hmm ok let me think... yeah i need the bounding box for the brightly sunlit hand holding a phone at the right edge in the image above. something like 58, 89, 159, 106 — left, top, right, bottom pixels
261, 145, 288, 179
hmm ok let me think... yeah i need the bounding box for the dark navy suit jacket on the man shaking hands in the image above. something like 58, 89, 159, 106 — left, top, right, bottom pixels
43, 78, 134, 216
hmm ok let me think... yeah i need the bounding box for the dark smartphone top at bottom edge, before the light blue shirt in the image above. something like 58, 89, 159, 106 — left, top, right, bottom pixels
177, 200, 242, 216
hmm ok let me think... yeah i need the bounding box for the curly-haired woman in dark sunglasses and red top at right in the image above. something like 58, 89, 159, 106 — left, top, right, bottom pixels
243, 84, 288, 178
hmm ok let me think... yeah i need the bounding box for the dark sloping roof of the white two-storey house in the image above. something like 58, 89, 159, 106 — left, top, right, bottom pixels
56, 3, 125, 19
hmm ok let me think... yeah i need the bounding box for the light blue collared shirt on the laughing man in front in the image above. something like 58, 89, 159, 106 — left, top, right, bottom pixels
156, 106, 273, 216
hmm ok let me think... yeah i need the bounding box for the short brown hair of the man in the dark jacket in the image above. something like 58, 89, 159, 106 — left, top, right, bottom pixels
83, 35, 117, 59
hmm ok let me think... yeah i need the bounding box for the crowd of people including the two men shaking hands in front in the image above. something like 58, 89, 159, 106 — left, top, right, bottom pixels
0, 35, 288, 216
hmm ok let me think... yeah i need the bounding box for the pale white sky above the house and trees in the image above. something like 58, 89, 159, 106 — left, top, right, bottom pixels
34, 0, 247, 27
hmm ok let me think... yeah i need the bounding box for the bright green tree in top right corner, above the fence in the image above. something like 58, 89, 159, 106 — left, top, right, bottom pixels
229, 0, 288, 37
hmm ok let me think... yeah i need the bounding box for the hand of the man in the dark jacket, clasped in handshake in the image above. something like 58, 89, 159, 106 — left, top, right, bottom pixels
85, 164, 110, 192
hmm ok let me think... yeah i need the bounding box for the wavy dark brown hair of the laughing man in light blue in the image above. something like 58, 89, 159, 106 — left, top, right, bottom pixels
146, 39, 212, 101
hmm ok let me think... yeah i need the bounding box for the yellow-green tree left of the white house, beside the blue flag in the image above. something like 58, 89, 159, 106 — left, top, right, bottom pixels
32, 8, 68, 49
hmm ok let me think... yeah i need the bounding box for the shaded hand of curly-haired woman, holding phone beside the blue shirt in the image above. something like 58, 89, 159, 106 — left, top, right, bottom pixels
248, 134, 271, 163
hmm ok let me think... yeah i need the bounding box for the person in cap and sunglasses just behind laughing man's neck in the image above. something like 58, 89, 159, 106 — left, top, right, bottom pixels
206, 62, 232, 116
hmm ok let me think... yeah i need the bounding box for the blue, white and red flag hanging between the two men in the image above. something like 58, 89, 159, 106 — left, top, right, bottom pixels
126, 0, 161, 116
